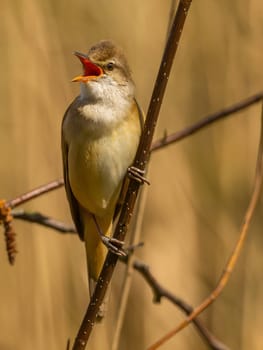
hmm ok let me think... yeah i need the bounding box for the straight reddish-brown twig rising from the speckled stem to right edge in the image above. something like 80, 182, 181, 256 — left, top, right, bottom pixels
151, 92, 263, 152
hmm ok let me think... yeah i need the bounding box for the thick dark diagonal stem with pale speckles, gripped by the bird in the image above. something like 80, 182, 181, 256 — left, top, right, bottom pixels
73, 0, 194, 350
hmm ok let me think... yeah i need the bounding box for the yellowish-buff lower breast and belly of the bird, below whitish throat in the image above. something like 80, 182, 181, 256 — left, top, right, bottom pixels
65, 102, 140, 215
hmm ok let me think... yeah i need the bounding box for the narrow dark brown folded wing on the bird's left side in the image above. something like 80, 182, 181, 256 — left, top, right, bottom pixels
61, 101, 84, 240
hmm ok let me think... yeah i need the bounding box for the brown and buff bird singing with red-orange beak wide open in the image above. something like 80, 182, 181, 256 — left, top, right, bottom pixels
61, 40, 144, 306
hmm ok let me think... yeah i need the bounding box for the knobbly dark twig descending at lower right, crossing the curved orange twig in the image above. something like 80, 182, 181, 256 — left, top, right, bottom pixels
133, 260, 229, 350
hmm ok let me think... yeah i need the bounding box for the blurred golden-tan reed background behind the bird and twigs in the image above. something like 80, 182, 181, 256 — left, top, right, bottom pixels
0, 0, 263, 350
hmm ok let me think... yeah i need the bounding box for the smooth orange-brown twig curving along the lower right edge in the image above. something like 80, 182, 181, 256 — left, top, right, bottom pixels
148, 105, 263, 350
